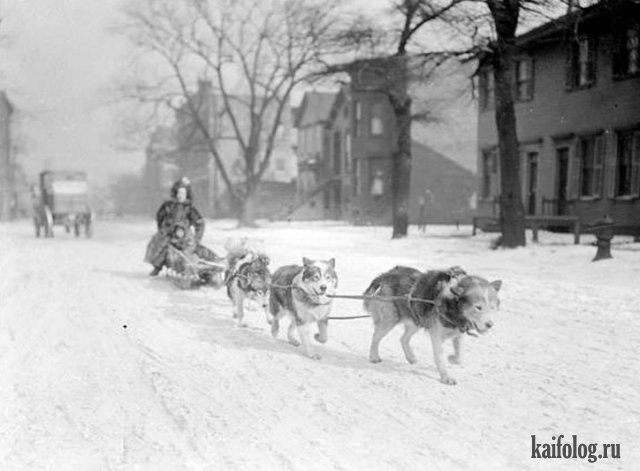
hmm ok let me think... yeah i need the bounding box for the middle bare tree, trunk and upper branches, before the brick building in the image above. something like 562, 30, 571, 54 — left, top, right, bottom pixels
327, 0, 464, 239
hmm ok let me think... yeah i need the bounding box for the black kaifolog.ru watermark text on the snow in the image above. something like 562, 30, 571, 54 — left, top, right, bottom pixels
531, 435, 620, 463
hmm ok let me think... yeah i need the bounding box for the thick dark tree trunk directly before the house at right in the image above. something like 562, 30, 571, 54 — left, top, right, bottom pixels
490, 0, 526, 248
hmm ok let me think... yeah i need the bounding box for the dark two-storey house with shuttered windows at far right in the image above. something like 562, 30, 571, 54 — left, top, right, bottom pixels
477, 0, 640, 229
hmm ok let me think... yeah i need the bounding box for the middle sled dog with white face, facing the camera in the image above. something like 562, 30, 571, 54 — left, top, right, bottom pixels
269, 258, 338, 360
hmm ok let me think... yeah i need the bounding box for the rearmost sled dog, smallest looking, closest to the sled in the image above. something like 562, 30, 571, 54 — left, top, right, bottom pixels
225, 252, 271, 327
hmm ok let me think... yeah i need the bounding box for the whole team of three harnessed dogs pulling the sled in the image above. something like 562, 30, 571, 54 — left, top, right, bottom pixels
225, 239, 501, 384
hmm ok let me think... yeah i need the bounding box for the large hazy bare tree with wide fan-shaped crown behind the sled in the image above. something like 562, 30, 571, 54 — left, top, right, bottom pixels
121, 0, 339, 225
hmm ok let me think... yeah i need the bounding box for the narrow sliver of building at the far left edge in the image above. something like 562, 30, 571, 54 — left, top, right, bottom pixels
0, 91, 18, 221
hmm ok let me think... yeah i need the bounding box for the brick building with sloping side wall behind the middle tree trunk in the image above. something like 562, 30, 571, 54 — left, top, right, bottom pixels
293, 63, 476, 223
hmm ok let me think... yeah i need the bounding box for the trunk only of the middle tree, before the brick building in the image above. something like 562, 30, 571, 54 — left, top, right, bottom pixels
390, 57, 411, 239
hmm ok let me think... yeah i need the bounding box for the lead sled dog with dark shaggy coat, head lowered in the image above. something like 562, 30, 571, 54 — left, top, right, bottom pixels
364, 266, 502, 384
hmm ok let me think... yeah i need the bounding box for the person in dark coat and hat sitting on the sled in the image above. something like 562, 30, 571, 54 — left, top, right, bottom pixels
144, 177, 204, 276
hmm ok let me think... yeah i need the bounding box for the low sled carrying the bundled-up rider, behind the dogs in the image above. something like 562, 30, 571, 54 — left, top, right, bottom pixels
167, 245, 227, 289
